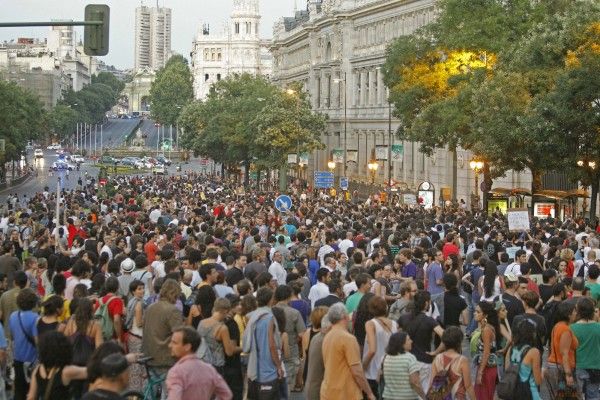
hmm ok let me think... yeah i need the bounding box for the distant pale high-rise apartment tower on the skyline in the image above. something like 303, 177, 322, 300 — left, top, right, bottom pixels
134, 6, 171, 71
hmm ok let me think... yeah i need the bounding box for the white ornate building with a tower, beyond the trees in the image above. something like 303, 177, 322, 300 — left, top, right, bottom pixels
191, 0, 272, 99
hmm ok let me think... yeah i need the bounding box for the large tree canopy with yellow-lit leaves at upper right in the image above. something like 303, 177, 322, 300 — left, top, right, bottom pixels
384, 0, 600, 195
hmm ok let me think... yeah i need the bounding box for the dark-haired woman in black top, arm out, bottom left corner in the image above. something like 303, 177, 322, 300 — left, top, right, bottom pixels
27, 331, 87, 400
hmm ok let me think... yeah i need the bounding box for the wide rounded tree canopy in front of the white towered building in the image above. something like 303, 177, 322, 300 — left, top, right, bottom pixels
178, 74, 326, 181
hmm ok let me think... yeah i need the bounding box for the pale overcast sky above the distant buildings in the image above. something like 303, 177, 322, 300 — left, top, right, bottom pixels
0, 0, 298, 69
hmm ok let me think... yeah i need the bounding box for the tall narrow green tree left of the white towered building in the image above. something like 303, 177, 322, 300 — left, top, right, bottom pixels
150, 55, 194, 125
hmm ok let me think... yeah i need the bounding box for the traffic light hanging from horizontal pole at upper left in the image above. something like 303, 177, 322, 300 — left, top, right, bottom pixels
83, 4, 110, 56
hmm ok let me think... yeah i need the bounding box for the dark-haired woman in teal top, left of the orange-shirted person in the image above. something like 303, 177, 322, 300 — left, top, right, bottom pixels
508, 319, 542, 400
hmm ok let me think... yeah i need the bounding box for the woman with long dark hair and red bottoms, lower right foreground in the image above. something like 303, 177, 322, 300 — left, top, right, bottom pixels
473, 301, 501, 400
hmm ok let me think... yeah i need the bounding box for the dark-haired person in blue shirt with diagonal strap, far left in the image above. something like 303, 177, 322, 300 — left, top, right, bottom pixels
8, 288, 39, 400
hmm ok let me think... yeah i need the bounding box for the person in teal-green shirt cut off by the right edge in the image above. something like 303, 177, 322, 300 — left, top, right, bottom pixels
570, 297, 600, 399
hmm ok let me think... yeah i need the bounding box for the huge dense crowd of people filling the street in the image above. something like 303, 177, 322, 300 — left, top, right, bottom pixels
0, 172, 600, 400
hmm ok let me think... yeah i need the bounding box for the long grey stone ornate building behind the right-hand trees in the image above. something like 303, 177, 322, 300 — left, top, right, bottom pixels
271, 0, 531, 206
